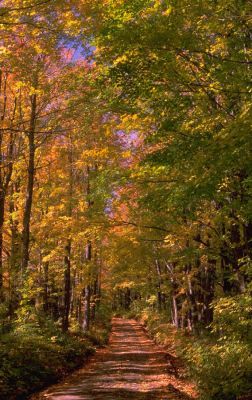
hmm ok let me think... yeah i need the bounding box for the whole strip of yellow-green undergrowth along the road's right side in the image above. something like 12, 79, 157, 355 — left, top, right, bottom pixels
121, 289, 252, 400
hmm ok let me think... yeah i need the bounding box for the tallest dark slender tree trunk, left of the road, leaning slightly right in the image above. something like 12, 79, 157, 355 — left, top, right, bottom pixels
22, 94, 37, 275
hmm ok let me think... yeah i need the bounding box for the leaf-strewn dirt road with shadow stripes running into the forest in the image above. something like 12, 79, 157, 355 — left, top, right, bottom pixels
31, 318, 196, 400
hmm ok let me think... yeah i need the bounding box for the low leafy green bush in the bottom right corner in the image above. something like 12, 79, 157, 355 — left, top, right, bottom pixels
185, 341, 252, 400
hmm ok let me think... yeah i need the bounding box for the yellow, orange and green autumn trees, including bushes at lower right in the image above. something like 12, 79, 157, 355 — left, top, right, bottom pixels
0, 0, 252, 399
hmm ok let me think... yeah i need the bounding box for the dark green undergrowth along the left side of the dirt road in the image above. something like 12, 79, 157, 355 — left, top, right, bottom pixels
0, 320, 109, 400
